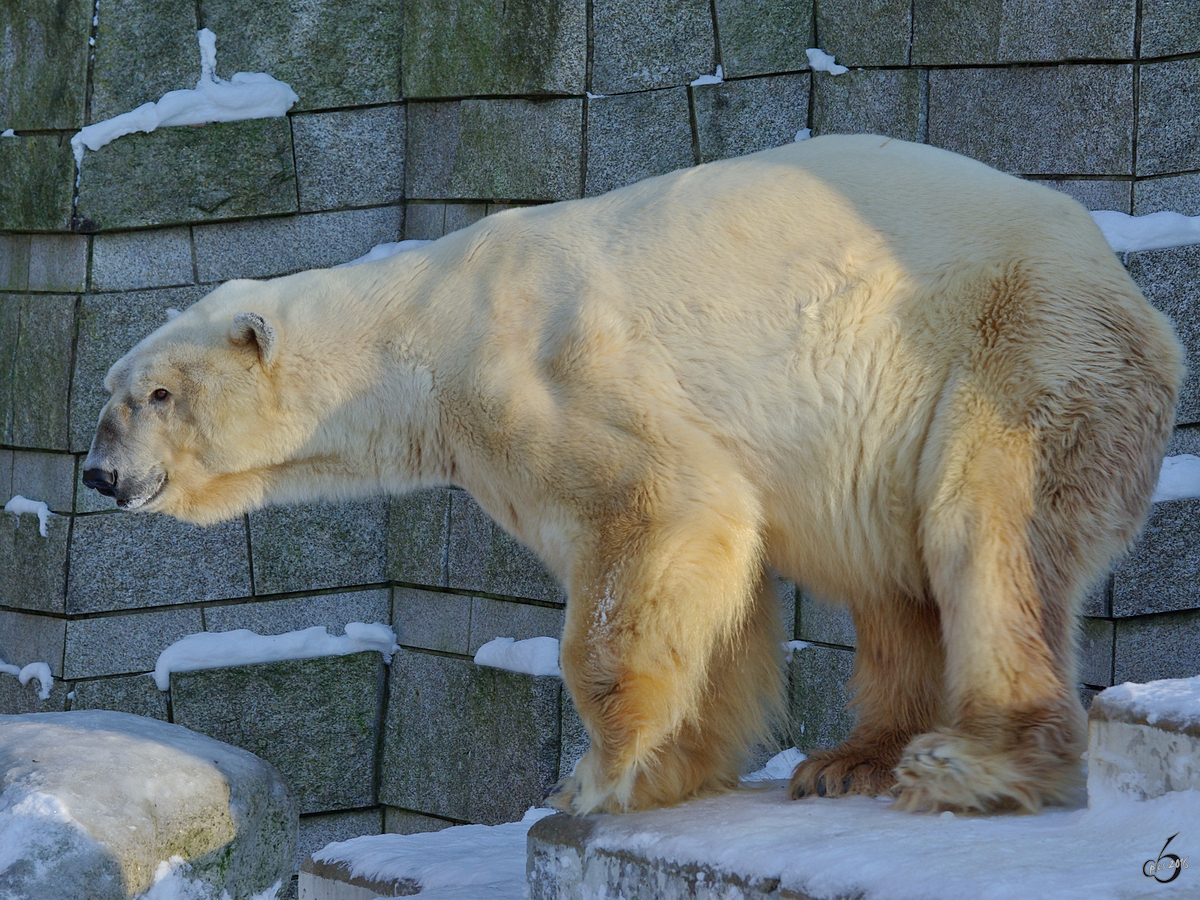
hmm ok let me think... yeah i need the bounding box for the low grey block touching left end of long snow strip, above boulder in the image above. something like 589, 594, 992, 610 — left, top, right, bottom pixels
62, 606, 204, 679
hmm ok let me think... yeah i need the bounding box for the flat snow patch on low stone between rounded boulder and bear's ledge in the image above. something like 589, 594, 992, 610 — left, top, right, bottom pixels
313, 809, 553, 900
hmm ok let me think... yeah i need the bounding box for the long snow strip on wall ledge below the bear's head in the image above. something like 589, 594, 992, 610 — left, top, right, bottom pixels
154, 622, 400, 691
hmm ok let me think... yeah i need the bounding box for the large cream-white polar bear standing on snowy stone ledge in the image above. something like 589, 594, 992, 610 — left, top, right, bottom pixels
84, 136, 1182, 814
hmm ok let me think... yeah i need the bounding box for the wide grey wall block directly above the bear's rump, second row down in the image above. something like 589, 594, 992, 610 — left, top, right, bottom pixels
929, 65, 1141, 175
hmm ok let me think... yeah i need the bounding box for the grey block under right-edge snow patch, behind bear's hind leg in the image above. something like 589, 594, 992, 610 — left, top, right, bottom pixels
1112, 500, 1200, 618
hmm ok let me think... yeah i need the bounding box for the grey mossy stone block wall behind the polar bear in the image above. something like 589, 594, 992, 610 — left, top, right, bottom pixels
0, 0, 1200, 878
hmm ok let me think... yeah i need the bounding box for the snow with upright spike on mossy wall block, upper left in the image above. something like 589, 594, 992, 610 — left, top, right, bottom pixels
71, 28, 299, 166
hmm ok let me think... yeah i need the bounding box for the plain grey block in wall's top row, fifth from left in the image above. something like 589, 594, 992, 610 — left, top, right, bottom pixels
592, 0, 715, 94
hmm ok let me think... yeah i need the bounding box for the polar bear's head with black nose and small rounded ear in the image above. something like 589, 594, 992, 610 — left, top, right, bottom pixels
83, 282, 281, 523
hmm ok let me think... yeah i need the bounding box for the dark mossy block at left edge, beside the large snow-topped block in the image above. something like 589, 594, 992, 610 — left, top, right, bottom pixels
0, 133, 74, 232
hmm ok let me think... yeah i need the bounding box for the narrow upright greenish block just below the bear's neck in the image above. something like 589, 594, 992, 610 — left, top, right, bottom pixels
388, 487, 450, 587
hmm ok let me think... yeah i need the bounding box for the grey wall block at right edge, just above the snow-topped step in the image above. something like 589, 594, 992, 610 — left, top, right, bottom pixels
1112, 610, 1200, 684
